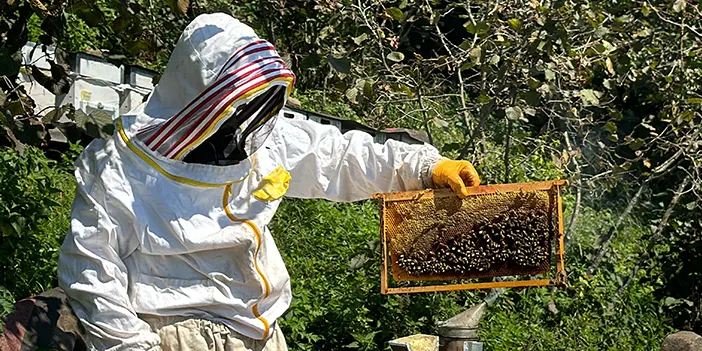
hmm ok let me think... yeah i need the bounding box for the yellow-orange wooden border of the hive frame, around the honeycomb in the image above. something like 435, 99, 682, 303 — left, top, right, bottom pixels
374, 180, 567, 294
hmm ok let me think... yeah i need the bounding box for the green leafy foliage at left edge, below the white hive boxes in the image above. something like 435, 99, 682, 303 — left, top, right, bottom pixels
0, 147, 75, 298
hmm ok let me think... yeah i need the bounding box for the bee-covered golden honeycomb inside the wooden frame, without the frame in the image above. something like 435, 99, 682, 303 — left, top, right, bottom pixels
383, 190, 556, 281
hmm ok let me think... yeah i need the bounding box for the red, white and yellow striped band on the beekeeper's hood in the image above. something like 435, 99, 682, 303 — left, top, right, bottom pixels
138, 40, 295, 160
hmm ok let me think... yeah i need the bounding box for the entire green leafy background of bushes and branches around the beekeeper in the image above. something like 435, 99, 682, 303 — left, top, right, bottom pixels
0, 0, 702, 350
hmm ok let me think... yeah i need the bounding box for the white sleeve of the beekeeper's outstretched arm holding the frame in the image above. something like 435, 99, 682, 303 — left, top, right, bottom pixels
273, 118, 441, 202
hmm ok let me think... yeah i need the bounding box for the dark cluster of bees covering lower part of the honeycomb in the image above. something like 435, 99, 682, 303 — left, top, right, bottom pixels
397, 207, 550, 276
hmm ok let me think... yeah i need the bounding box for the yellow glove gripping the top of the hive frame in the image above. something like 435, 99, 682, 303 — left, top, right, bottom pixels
431, 160, 480, 198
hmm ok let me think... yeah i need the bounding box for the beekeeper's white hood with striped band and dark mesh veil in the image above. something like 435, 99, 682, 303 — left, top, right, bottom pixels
129, 14, 295, 164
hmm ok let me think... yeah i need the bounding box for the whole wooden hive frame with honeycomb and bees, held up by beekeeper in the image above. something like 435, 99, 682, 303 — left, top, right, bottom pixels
375, 180, 566, 293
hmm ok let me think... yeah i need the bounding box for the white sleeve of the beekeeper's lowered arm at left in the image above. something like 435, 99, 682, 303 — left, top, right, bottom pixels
58, 151, 160, 351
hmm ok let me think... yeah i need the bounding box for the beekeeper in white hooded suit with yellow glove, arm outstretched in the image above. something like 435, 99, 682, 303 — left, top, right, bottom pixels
58, 14, 480, 350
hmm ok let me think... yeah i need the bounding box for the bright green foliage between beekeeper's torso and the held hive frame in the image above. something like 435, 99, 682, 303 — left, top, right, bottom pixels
271, 200, 470, 350
